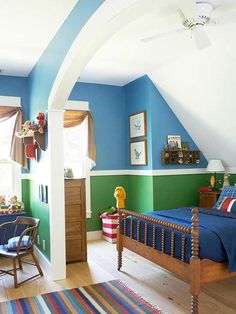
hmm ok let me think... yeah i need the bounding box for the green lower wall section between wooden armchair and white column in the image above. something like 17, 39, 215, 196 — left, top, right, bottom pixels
22, 179, 50, 260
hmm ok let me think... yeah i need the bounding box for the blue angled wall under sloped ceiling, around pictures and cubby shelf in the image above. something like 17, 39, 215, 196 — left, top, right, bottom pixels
124, 76, 207, 170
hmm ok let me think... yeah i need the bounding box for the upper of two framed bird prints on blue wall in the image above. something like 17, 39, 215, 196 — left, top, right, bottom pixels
129, 111, 147, 138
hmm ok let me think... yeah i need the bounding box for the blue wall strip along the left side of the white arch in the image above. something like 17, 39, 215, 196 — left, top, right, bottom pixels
29, 0, 103, 119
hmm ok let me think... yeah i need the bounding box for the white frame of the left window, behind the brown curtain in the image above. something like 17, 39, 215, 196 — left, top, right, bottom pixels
0, 96, 22, 201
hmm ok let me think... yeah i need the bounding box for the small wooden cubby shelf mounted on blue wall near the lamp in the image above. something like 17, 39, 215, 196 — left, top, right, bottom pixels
161, 149, 200, 165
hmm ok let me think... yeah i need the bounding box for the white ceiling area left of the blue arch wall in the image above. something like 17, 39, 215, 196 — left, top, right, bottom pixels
0, 0, 77, 76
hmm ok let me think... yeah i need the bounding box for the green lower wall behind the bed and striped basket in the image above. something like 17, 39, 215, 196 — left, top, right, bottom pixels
87, 174, 210, 231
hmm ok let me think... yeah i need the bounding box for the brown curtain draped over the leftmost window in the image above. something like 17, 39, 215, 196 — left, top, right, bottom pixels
0, 107, 28, 169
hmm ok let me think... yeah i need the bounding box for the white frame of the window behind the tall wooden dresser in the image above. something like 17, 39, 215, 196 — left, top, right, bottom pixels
64, 100, 92, 218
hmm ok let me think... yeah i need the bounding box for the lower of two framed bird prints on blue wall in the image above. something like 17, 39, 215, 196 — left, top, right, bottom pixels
130, 140, 147, 166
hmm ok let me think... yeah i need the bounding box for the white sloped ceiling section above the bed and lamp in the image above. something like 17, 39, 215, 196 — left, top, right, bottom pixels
149, 40, 236, 171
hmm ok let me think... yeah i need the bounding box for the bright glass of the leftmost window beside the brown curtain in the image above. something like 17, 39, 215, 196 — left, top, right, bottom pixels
0, 116, 21, 198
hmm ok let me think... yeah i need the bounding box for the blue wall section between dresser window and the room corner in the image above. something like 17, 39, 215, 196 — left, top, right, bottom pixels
69, 83, 128, 170
